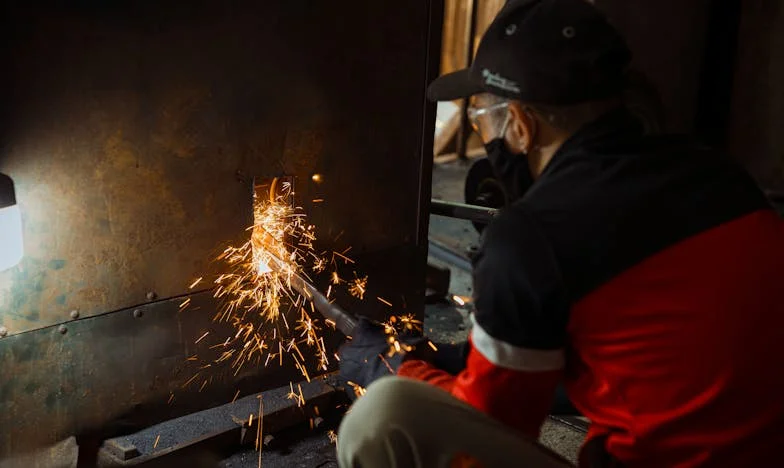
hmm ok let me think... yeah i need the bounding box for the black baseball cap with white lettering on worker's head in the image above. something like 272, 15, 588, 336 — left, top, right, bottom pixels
427, 0, 631, 105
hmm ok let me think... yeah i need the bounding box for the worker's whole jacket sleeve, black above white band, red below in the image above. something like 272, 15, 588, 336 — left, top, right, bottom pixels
398, 203, 571, 437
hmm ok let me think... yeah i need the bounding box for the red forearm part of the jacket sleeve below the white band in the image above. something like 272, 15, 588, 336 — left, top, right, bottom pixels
398, 338, 562, 438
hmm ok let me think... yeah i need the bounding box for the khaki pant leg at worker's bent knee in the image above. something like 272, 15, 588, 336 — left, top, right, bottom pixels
338, 377, 572, 468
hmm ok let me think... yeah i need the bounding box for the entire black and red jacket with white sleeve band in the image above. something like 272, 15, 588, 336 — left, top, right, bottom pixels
399, 111, 784, 467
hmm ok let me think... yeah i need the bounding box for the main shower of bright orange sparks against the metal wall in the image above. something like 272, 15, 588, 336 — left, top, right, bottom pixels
180, 179, 367, 386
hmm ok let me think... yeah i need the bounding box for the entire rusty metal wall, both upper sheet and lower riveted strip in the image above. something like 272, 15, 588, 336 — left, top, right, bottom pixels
0, 0, 441, 457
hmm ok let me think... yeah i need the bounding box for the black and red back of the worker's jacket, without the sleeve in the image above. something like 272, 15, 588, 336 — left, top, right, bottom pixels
517, 109, 784, 467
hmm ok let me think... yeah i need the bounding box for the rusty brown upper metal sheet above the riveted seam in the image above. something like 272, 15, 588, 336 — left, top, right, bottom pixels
0, 0, 434, 335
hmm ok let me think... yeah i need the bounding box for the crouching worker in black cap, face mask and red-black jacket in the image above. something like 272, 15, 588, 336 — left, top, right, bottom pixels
338, 0, 784, 468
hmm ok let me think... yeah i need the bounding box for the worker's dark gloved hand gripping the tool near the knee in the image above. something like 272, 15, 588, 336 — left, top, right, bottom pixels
338, 317, 427, 388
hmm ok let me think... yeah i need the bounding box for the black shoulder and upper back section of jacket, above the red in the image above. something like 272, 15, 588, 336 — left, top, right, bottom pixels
516, 111, 770, 301
